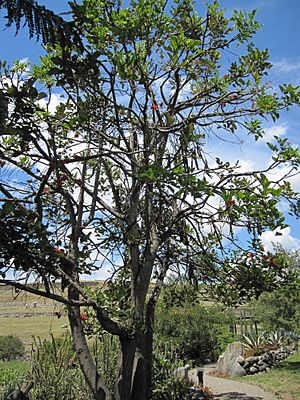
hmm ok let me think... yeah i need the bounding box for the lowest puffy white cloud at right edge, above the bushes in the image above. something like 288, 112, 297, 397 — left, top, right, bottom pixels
261, 227, 300, 251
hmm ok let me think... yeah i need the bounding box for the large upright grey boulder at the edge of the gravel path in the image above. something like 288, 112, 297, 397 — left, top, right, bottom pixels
217, 342, 246, 376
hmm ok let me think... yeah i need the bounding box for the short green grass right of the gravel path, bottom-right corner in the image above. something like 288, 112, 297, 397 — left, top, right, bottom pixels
235, 352, 300, 400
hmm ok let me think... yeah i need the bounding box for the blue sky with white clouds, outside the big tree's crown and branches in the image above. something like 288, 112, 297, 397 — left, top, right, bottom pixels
0, 0, 300, 256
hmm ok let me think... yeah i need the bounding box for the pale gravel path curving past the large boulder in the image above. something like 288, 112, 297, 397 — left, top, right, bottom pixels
204, 368, 276, 400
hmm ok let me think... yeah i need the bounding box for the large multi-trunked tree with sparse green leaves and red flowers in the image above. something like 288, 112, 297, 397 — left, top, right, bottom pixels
0, 0, 300, 400
